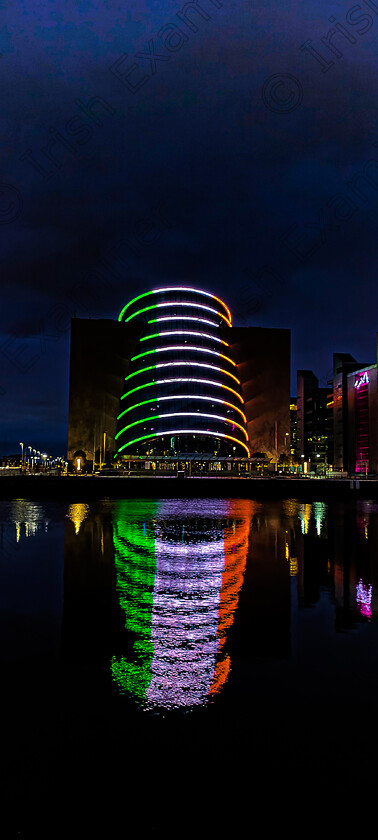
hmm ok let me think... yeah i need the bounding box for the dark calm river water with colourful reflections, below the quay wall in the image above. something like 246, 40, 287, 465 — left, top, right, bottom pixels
0, 499, 378, 838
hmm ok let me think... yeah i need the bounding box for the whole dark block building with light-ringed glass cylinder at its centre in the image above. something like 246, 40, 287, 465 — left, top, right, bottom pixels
68, 286, 290, 471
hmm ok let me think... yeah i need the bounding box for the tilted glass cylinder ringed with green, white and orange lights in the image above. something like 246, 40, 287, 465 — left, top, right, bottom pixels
116, 286, 249, 457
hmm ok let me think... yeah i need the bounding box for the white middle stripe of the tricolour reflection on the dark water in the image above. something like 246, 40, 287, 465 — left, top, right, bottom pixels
147, 535, 225, 707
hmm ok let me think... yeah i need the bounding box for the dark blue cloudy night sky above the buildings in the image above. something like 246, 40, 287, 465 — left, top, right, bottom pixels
0, 0, 378, 455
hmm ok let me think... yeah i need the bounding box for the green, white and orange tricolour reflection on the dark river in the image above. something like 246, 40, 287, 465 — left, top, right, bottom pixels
111, 501, 258, 708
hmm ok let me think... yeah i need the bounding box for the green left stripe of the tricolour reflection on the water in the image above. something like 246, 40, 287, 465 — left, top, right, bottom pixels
111, 501, 157, 699
